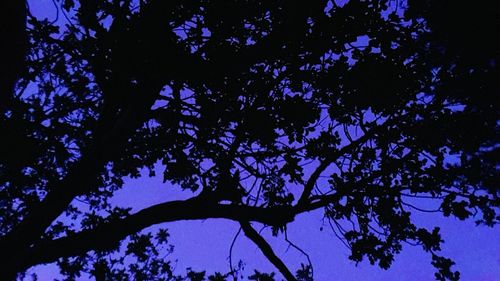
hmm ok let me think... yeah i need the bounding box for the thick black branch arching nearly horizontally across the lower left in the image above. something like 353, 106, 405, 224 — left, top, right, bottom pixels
24, 198, 295, 267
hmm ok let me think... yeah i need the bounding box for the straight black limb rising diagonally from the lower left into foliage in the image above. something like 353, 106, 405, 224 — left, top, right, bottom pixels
0, 80, 161, 263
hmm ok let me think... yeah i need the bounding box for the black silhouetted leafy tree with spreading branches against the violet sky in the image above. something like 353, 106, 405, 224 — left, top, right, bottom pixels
0, 0, 500, 280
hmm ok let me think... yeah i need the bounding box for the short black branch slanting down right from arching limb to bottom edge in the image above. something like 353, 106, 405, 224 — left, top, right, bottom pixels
240, 221, 297, 281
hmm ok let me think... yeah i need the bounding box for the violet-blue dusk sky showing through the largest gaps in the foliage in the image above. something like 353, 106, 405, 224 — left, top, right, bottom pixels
28, 0, 500, 281
